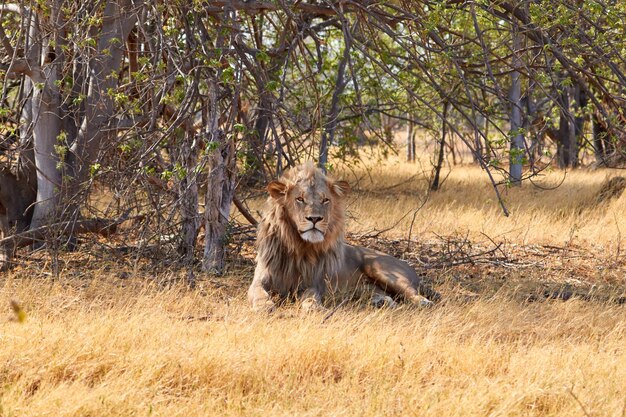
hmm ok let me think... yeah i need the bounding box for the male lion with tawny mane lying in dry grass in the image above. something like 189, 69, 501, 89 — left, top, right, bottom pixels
248, 162, 439, 311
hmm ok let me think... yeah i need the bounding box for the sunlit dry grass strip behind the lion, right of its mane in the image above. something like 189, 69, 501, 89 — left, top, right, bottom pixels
337, 153, 626, 251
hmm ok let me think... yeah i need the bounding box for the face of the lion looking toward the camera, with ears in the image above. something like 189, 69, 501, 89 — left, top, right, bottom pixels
267, 167, 349, 243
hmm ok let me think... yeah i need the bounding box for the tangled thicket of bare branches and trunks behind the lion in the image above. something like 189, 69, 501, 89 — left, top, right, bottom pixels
0, 0, 626, 273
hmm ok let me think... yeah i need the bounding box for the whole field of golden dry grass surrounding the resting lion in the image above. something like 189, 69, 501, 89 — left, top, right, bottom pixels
0, 160, 626, 417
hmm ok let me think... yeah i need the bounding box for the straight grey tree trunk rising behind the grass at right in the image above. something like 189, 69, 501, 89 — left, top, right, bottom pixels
509, 23, 524, 185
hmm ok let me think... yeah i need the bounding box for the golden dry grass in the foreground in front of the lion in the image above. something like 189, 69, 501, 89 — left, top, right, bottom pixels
0, 279, 626, 416
